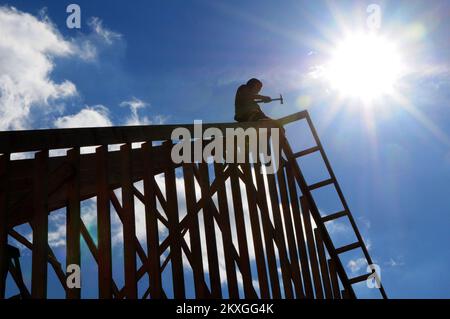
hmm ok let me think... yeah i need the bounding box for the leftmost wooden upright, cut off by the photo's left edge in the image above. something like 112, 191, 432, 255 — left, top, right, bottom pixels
0, 154, 9, 299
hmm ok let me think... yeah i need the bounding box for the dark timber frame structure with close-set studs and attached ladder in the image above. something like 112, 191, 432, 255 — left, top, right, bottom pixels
0, 111, 387, 299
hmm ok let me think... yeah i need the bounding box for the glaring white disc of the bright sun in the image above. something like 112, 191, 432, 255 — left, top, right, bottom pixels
326, 33, 402, 104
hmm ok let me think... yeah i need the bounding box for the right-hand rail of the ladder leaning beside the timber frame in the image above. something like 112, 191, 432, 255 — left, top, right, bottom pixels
305, 112, 387, 299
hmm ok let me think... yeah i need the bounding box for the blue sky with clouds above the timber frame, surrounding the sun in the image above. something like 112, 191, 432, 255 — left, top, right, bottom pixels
0, 0, 450, 298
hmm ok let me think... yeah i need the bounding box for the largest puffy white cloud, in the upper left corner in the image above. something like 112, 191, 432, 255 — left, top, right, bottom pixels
0, 7, 77, 130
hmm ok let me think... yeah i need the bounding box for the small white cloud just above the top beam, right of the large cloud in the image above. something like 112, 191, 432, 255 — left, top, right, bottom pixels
54, 105, 112, 128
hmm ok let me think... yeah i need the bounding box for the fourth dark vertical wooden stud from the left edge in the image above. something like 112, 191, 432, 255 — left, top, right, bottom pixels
96, 145, 112, 299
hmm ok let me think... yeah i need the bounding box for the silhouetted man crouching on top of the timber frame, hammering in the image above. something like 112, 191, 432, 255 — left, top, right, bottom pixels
234, 78, 272, 122
